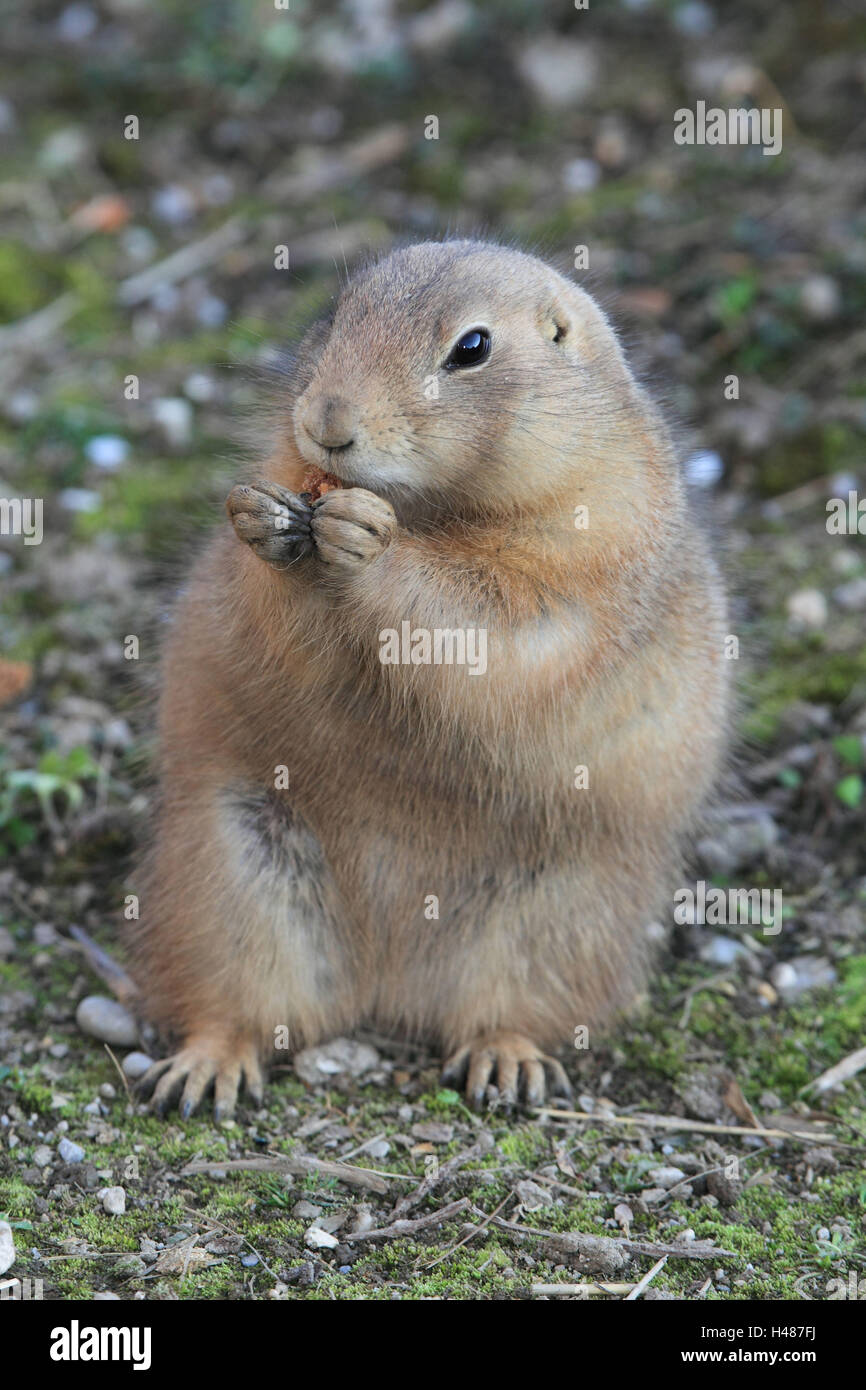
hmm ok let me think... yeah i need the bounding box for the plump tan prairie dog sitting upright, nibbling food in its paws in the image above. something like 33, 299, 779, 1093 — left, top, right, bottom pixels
136, 240, 727, 1118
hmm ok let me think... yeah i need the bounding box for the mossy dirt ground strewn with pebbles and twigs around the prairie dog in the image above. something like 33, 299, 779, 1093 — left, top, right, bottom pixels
0, 0, 866, 1301
